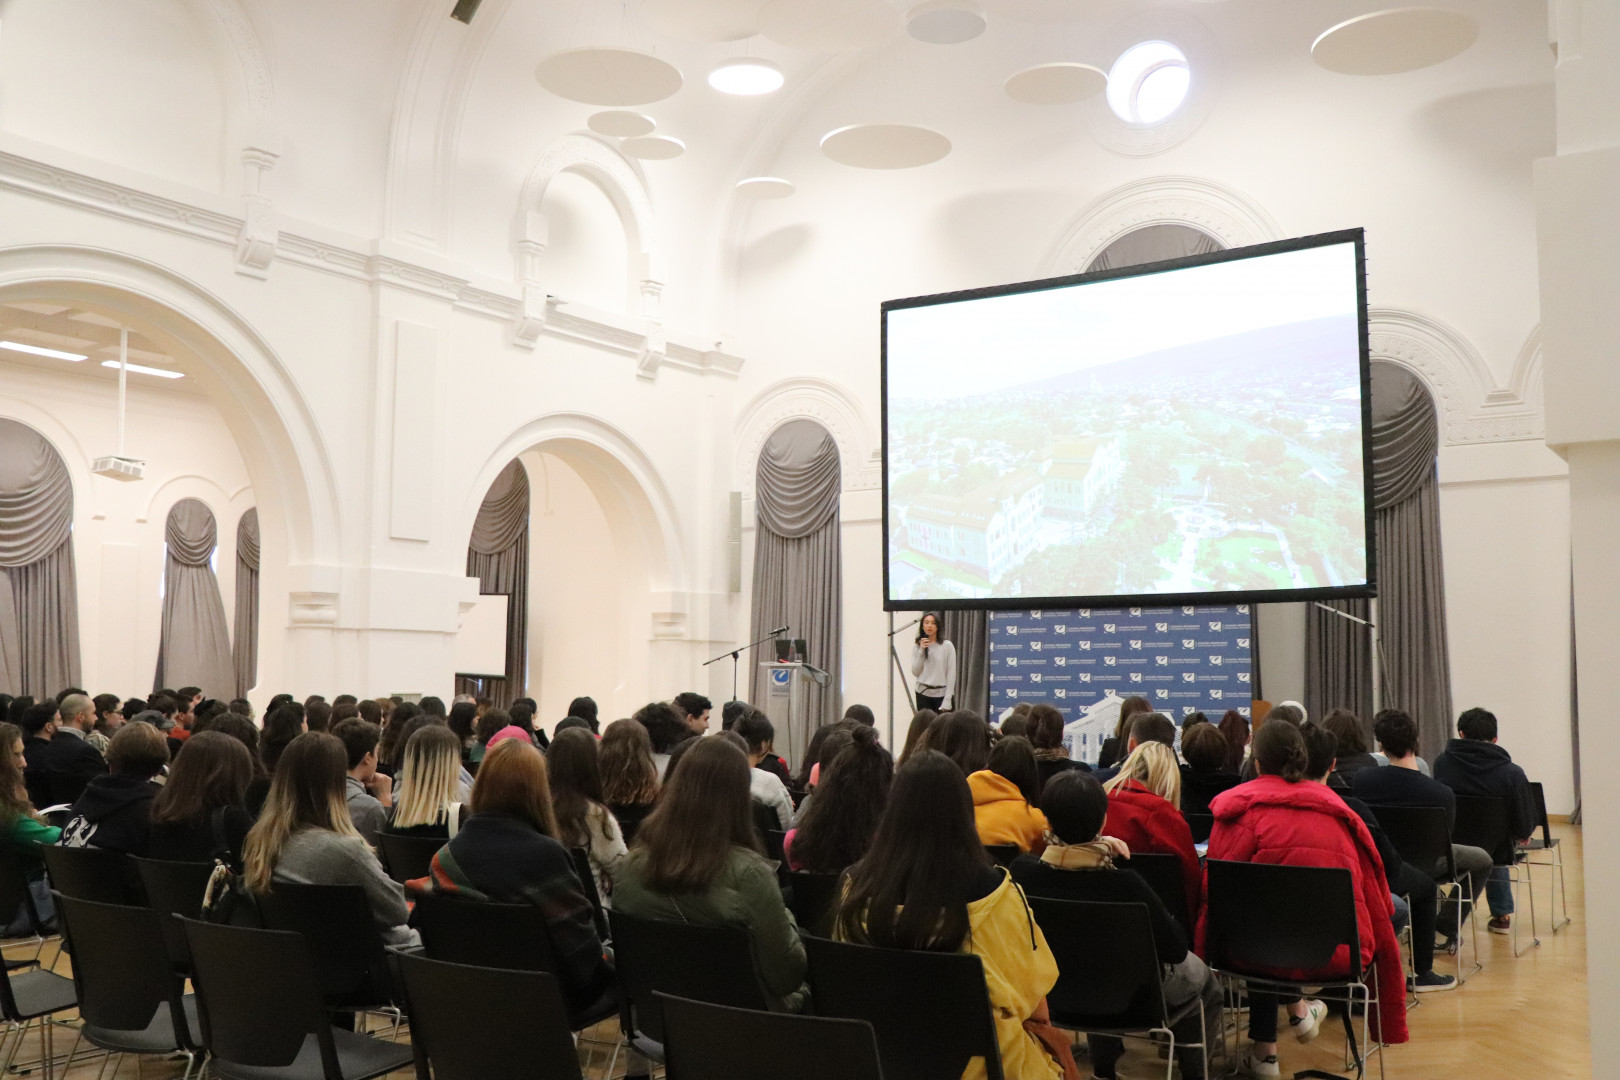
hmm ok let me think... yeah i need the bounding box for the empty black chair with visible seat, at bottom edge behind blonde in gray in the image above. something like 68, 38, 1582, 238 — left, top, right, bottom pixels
185, 920, 414, 1080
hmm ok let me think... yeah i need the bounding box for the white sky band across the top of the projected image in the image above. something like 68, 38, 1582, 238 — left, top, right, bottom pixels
888, 243, 1358, 398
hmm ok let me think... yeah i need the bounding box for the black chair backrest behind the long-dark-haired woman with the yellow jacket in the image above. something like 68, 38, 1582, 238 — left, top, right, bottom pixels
805, 938, 1003, 1080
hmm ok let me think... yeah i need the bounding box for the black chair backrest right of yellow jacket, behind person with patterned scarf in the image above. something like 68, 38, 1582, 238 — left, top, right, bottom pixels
1029, 897, 1165, 1031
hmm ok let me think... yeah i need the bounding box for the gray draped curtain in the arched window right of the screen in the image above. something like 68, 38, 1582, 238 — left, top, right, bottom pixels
1306, 361, 1452, 758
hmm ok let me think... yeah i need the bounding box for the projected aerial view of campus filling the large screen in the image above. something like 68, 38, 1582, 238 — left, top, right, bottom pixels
886, 244, 1366, 601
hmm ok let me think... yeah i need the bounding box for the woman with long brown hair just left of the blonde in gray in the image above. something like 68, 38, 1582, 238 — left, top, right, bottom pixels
146, 730, 254, 868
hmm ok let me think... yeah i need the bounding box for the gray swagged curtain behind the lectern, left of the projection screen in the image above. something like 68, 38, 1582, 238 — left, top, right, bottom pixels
748, 419, 844, 738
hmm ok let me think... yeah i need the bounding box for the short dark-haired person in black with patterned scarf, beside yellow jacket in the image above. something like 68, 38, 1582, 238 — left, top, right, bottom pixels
1013, 773, 1221, 1080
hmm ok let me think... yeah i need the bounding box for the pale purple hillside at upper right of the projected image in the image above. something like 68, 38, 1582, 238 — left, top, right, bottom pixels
1001, 314, 1359, 393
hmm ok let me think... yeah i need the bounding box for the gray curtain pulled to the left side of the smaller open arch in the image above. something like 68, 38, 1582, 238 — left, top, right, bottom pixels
467, 458, 528, 708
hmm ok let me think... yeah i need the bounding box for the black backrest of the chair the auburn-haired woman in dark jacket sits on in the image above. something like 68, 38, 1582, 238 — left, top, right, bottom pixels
410, 892, 557, 975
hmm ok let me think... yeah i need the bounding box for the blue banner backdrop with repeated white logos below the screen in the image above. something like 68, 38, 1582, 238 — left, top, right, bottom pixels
990, 604, 1254, 763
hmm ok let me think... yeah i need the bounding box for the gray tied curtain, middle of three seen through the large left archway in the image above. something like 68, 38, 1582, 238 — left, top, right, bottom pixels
152, 499, 237, 698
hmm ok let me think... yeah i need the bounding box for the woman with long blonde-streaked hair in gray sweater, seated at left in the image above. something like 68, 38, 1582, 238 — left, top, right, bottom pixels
241, 729, 417, 946
